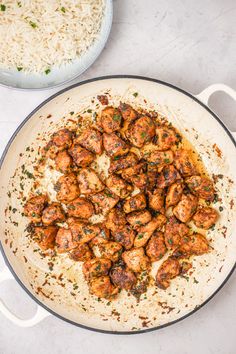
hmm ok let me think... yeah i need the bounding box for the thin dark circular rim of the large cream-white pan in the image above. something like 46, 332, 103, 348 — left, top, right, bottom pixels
0, 75, 236, 335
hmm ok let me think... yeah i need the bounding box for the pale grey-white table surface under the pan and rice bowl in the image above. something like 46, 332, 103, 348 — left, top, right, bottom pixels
0, 0, 236, 354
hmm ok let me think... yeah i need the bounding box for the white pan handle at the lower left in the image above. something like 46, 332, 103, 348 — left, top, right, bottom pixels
0, 266, 51, 327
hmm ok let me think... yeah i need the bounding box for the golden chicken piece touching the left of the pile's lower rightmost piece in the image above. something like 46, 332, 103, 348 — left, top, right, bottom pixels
173, 194, 198, 222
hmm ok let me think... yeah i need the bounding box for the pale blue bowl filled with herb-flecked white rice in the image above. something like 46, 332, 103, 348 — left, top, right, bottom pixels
0, 0, 113, 89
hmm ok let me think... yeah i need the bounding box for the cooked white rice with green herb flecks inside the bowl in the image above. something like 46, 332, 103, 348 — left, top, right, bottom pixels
0, 0, 105, 73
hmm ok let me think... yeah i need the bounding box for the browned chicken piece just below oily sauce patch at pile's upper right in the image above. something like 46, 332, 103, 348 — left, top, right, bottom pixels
174, 149, 196, 177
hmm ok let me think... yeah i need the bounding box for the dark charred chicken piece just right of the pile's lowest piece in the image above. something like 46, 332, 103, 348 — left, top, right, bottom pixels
110, 265, 137, 290
